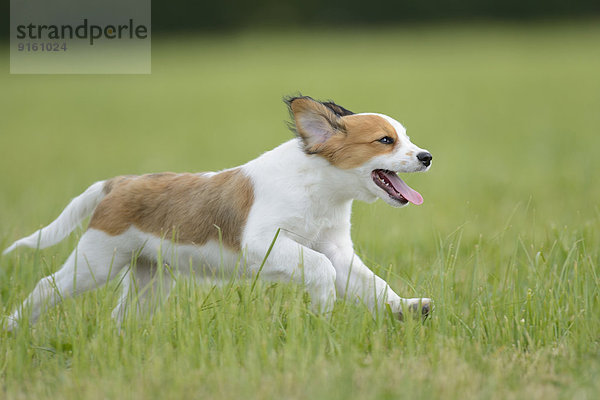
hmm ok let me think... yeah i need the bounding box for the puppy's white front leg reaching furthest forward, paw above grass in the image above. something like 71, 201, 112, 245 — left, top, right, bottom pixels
320, 241, 432, 318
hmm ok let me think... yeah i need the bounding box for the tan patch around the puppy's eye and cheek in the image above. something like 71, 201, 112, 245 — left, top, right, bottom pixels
318, 115, 400, 169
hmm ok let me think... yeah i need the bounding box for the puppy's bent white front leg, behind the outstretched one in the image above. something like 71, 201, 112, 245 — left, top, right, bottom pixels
245, 234, 336, 313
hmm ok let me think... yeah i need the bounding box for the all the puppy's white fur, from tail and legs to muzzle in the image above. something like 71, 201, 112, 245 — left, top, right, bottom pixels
5, 114, 430, 329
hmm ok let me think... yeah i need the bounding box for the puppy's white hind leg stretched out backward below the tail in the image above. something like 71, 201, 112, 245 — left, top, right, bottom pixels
5, 229, 131, 330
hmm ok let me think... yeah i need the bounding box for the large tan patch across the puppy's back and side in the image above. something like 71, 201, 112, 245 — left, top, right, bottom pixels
89, 169, 254, 250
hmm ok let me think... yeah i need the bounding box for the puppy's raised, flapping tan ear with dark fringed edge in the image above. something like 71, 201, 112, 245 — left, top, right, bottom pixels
285, 96, 347, 154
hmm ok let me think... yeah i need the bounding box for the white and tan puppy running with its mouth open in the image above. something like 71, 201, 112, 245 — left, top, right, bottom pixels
4, 96, 432, 329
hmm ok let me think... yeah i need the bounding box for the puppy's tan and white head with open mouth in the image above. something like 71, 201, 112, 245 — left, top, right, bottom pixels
285, 96, 432, 207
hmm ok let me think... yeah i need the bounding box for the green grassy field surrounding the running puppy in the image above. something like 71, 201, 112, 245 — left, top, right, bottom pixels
0, 21, 600, 399
